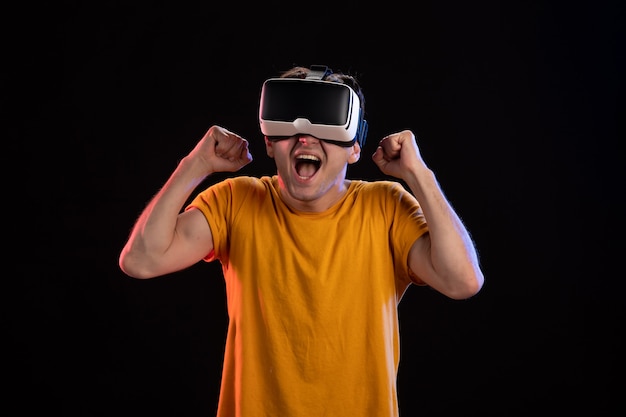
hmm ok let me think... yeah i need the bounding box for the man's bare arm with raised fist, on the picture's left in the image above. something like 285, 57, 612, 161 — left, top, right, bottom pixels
119, 126, 252, 278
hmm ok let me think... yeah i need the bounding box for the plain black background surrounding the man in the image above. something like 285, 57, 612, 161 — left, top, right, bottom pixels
8, 1, 626, 417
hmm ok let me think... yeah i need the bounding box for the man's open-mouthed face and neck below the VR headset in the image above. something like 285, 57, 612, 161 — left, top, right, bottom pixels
265, 135, 361, 211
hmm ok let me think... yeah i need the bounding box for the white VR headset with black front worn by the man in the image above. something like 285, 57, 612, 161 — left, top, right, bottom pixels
259, 65, 367, 147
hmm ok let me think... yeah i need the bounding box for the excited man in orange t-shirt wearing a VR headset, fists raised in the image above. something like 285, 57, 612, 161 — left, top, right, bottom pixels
119, 66, 483, 417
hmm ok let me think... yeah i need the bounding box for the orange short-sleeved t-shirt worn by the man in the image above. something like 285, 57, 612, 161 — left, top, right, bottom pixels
187, 176, 428, 417
